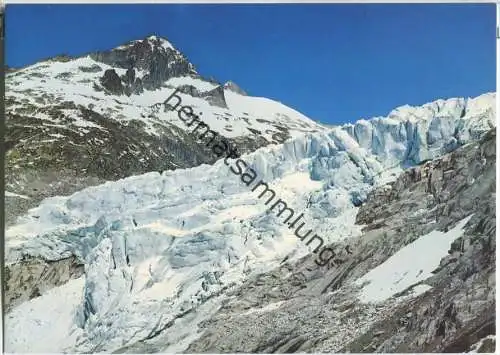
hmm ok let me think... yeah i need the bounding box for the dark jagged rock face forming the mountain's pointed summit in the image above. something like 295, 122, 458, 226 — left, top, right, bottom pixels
90, 36, 196, 93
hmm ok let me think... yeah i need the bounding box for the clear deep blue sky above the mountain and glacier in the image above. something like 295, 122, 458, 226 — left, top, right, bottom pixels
5, 4, 496, 124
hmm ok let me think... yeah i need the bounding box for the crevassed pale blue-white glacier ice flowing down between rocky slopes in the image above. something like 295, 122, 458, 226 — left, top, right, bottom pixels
6, 90, 495, 352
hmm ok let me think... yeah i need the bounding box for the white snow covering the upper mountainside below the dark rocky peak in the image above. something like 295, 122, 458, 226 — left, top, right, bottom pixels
6, 36, 323, 141
